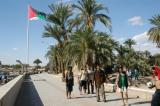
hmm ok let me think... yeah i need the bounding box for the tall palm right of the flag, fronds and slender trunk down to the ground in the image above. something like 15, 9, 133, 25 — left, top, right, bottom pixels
43, 3, 72, 78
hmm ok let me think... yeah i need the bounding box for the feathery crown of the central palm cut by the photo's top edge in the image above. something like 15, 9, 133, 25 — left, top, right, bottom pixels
73, 0, 111, 28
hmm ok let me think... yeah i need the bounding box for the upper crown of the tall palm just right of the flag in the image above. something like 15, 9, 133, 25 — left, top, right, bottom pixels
47, 3, 72, 40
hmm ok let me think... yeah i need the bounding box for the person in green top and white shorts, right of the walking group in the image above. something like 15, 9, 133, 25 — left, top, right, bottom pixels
116, 68, 128, 106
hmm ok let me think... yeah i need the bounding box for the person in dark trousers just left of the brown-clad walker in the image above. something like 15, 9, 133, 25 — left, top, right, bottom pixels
87, 66, 94, 94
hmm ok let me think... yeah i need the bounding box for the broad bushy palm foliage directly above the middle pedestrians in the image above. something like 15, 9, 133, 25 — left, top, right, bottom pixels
65, 30, 114, 67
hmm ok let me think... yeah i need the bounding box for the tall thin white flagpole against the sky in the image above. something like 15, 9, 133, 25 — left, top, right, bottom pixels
27, 5, 29, 69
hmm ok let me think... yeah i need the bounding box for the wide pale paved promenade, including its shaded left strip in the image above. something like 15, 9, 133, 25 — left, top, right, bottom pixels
15, 73, 150, 106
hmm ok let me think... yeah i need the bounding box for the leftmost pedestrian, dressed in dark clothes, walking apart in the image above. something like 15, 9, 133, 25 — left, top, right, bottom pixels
65, 66, 74, 99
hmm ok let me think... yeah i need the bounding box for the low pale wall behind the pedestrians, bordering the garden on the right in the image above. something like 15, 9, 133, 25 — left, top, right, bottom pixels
105, 84, 155, 99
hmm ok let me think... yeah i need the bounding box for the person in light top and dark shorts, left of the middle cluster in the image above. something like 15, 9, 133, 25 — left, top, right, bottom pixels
79, 68, 88, 95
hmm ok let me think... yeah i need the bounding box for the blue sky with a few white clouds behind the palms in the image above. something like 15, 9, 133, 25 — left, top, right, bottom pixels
0, 0, 160, 65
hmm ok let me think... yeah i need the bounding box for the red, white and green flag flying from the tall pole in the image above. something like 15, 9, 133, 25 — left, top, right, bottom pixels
28, 6, 46, 20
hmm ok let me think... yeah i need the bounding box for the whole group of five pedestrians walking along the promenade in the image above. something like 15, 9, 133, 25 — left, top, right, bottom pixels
66, 65, 128, 105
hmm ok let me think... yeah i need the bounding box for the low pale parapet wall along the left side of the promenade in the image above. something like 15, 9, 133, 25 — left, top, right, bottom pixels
0, 75, 24, 106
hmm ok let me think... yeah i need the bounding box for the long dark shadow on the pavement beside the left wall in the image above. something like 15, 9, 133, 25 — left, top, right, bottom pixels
14, 76, 44, 106
